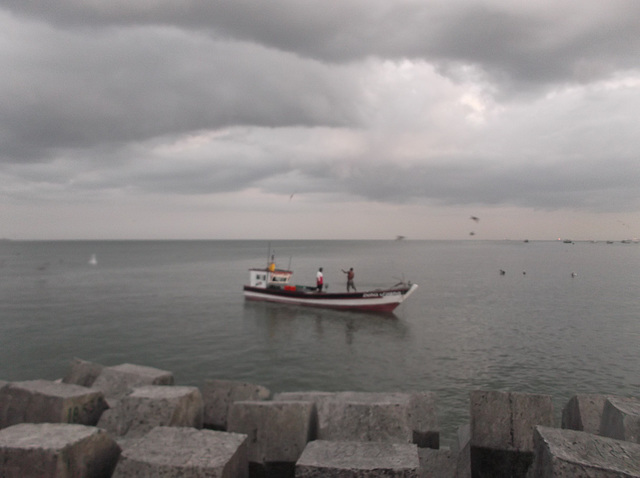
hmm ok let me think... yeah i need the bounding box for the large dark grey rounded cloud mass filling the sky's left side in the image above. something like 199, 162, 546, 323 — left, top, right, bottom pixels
0, 10, 357, 161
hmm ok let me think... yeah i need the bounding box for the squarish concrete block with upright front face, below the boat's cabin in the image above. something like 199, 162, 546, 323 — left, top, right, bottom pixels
227, 401, 317, 465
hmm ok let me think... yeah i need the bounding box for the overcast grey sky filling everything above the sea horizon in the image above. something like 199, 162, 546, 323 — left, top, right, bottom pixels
0, 0, 640, 240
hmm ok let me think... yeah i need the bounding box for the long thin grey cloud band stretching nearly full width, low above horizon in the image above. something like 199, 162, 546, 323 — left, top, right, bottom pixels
6, 145, 640, 212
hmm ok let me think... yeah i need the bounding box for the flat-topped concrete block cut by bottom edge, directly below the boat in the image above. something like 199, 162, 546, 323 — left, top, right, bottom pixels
295, 440, 420, 478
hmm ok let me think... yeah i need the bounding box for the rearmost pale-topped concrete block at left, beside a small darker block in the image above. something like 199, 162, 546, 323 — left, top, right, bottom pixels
93, 363, 174, 401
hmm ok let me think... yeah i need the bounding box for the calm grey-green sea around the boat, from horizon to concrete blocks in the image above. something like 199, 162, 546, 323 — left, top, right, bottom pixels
0, 241, 640, 444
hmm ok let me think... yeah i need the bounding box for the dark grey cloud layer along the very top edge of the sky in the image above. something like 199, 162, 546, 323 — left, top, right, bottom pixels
0, 0, 640, 91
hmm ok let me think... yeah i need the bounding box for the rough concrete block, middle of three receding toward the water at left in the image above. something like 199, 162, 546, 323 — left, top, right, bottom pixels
98, 385, 204, 438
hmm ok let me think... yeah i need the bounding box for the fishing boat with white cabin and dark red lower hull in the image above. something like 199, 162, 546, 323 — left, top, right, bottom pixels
244, 264, 418, 312
